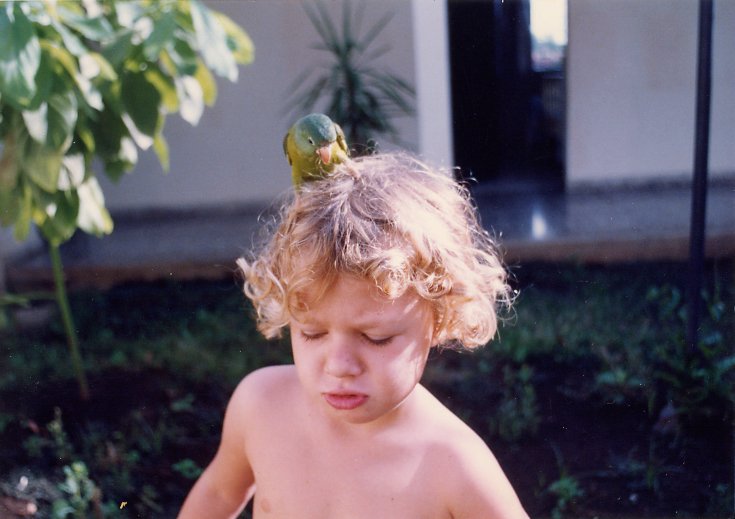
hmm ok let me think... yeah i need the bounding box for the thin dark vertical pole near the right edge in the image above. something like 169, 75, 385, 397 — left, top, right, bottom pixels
687, 0, 713, 355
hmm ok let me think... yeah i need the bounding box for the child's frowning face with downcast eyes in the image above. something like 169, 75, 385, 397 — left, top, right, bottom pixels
291, 275, 433, 423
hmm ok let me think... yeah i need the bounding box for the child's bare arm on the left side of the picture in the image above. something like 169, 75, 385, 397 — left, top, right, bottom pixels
179, 383, 255, 519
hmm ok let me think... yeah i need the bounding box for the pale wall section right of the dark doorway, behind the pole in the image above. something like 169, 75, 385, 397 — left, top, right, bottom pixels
567, 0, 735, 188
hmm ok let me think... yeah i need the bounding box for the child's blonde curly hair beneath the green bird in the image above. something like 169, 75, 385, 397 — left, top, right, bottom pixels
237, 153, 511, 349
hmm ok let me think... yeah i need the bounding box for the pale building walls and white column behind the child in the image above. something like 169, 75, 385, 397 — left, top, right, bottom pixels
0, 0, 735, 282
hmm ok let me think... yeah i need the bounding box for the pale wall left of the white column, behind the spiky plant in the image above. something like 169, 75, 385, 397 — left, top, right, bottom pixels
103, 0, 418, 214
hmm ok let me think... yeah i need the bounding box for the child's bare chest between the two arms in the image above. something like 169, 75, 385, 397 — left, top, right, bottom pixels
249, 424, 449, 519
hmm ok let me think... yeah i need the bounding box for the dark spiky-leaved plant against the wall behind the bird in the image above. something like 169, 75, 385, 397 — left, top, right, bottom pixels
290, 2, 414, 151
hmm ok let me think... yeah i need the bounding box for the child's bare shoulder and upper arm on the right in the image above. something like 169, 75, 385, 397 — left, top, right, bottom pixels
420, 388, 528, 519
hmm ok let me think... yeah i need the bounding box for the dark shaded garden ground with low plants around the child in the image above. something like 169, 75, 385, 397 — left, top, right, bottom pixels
0, 262, 735, 518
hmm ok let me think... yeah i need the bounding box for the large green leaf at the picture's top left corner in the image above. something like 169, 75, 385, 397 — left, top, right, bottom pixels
0, 2, 41, 106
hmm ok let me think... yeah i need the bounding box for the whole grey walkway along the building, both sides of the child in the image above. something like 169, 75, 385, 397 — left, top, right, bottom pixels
5, 180, 735, 291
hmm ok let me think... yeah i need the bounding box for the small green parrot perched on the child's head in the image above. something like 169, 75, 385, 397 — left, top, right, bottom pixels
283, 114, 350, 188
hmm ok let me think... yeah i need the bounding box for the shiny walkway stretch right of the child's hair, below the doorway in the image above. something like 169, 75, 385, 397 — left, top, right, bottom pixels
475, 181, 735, 263
